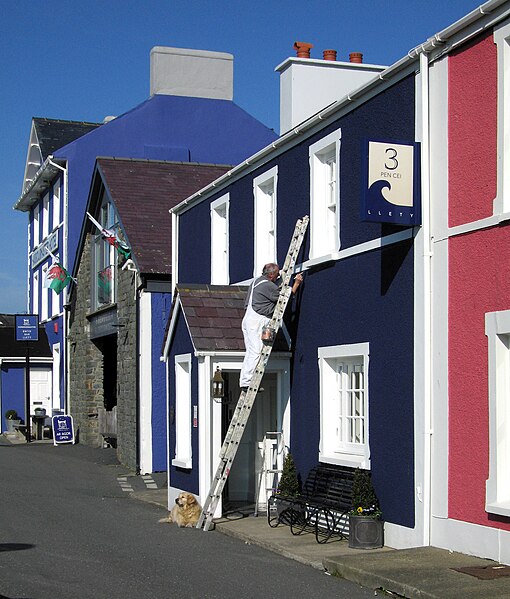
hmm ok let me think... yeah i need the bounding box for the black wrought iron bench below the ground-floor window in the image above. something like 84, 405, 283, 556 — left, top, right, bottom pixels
267, 464, 354, 543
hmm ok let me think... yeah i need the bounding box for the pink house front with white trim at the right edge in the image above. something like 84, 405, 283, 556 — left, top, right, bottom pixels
429, 2, 510, 564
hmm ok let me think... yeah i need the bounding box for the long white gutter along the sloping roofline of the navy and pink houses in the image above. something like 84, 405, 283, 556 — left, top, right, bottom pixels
170, 0, 510, 214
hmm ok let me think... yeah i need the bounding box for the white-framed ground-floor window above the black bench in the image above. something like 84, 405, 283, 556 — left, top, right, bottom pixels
319, 343, 370, 468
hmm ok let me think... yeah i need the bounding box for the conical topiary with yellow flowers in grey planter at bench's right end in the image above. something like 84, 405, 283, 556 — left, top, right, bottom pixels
349, 468, 384, 549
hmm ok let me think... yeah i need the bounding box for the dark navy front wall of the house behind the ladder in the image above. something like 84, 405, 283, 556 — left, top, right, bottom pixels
179, 76, 415, 527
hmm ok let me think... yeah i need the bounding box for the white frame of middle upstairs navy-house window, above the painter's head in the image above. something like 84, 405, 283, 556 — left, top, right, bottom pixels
253, 165, 278, 277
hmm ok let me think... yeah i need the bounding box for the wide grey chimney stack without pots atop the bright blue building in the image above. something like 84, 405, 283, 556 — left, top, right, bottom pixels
150, 46, 234, 100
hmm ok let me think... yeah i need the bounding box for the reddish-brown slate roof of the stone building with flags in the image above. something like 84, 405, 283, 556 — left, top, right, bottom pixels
97, 158, 230, 274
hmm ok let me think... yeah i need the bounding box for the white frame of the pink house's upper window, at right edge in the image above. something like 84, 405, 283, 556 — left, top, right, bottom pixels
494, 20, 510, 214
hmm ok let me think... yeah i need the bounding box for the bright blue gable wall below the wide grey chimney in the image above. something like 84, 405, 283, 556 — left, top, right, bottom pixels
55, 95, 276, 276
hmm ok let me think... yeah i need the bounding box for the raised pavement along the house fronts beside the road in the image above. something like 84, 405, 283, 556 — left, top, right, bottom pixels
0, 433, 510, 599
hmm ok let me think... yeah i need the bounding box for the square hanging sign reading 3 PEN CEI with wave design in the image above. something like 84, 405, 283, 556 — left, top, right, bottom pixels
361, 141, 421, 225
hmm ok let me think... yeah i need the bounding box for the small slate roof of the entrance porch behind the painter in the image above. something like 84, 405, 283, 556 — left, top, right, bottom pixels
174, 284, 289, 352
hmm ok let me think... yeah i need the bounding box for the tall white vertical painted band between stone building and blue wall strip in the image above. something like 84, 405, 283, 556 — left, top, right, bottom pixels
138, 291, 153, 474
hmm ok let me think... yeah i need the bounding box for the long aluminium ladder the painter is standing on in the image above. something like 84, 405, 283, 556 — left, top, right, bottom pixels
196, 216, 309, 531
